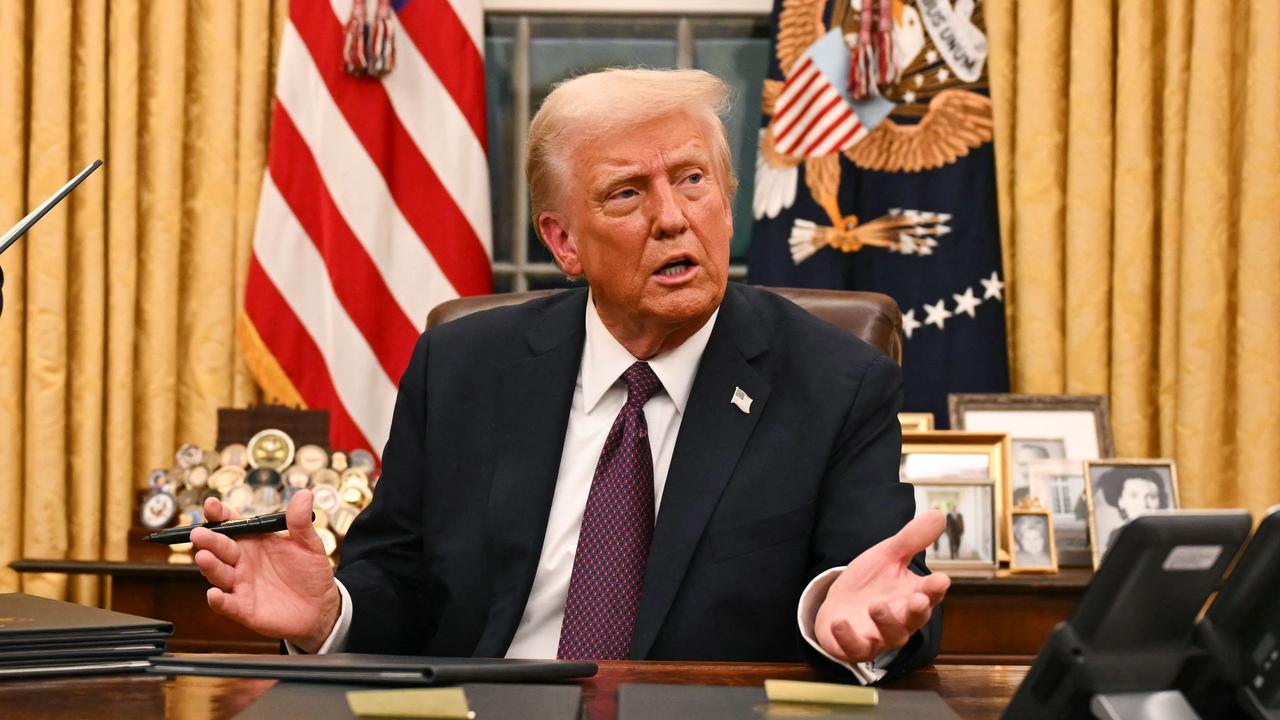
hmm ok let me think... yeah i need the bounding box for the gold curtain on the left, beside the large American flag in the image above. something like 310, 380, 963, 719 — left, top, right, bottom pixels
0, 0, 287, 602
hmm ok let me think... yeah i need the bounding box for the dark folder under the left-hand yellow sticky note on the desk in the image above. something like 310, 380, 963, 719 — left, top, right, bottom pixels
236, 683, 582, 720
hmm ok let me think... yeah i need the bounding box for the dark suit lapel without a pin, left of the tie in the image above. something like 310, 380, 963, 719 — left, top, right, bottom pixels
475, 291, 586, 657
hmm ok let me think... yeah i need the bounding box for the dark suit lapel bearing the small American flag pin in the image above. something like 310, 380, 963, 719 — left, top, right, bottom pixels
631, 286, 769, 659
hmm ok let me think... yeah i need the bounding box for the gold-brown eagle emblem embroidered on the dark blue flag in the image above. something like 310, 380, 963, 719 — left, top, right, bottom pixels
753, 0, 993, 263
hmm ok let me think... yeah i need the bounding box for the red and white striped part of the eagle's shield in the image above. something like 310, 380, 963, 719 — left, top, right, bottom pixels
769, 55, 867, 158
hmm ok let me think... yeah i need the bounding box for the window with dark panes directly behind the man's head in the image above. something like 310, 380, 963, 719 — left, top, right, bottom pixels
485, 8, 769, 292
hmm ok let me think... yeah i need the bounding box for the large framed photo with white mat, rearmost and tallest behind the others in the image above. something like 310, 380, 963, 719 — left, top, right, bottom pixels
947, 393, 1115, 460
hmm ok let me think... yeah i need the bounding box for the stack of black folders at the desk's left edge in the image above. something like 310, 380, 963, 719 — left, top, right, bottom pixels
0, 593, 173, 678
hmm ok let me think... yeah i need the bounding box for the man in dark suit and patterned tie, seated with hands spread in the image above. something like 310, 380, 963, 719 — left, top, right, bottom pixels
192, 65, 948, 682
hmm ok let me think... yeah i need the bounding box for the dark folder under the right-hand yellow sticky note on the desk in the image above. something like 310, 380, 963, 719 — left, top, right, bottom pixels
618, 683, 960, 720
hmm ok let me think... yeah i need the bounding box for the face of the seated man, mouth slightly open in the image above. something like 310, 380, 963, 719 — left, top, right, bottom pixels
539, 114, 733, 331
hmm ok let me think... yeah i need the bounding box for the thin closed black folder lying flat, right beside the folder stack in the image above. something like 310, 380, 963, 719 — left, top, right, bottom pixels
148, 652, 595, 687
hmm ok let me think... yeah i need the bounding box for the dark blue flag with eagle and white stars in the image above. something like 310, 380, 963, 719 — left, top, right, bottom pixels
748, 0, 1009, 427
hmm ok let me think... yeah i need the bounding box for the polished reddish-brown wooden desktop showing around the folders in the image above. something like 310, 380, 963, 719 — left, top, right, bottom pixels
0, 662, 1027, 720
